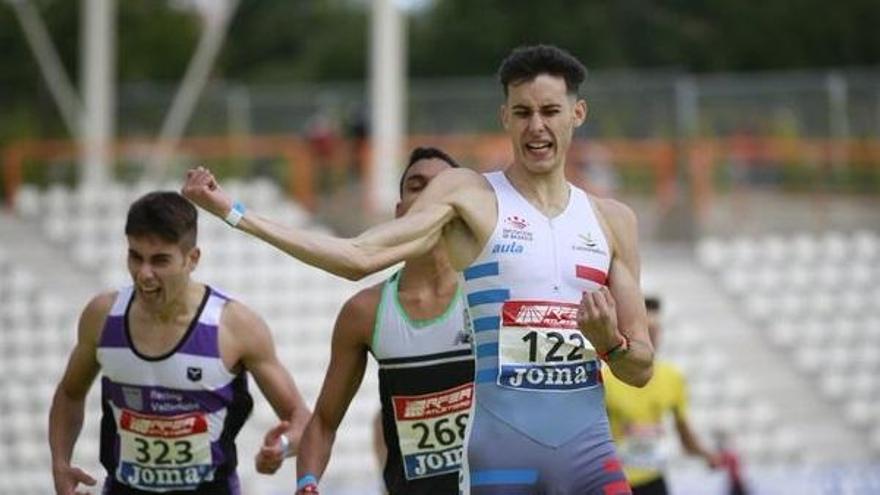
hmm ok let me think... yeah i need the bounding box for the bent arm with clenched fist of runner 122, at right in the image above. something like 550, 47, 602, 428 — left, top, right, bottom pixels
579, 199, 654, 387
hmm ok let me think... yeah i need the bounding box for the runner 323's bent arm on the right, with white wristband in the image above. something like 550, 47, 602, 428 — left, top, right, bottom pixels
222, 301, 311, 474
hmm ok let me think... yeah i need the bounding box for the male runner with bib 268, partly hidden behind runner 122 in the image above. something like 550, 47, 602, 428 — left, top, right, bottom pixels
297, 148, 474, 495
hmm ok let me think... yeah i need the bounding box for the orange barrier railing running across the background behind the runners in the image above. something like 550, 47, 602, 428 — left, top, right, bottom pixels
2, 134, 880, 212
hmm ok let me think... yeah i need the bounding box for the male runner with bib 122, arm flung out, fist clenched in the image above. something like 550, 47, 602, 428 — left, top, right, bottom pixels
183, 45, 653, 495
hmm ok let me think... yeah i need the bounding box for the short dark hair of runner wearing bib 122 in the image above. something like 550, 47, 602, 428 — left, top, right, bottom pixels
498, 45, 587, 97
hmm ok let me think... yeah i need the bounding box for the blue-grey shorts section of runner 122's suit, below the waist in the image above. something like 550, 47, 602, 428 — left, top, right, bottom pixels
459, 403, 632, 495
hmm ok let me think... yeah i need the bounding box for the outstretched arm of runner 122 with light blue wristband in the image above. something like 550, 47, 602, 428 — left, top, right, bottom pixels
182, 167, 478, 280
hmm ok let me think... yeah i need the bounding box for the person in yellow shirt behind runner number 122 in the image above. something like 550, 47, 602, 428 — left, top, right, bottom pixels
602, 297, 717, 495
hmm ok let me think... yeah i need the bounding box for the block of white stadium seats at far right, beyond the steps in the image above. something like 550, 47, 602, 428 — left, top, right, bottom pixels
697, 230, 880, 454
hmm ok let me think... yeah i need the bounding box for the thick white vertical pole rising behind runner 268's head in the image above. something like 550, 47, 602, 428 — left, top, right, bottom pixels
367, 0, 406, 213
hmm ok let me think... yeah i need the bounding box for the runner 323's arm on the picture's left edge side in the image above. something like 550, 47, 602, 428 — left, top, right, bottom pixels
49, 294, 113, 495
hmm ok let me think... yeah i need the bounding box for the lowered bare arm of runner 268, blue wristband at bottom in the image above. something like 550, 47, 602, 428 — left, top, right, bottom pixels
296, 287, 380, 494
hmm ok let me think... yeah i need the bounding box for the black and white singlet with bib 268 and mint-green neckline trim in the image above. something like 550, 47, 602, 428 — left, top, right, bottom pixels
370, 272, 474, 495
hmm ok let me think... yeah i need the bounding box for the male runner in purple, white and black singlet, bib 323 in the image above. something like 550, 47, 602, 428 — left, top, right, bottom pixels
49, 192, 309, 495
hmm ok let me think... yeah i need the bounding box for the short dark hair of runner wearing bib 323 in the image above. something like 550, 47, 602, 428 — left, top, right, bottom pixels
125, 191, 199, 252
